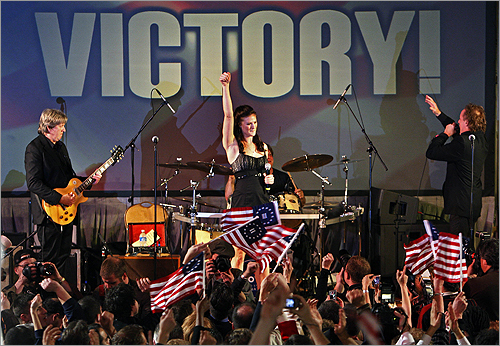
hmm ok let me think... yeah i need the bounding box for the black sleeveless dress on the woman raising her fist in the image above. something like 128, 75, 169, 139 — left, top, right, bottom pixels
231, 153, 269, 208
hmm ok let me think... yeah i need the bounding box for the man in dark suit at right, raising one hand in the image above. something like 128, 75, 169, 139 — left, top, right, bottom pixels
425, 96, 488, 236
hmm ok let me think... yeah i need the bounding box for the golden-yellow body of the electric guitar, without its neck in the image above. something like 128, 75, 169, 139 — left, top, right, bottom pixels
42, 178, 88, 225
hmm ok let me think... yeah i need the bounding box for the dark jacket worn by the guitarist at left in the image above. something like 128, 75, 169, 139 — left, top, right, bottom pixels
24, 134, 76, 224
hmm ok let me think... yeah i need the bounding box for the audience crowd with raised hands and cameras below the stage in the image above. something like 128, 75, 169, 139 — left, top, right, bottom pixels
1, 239, 499, 345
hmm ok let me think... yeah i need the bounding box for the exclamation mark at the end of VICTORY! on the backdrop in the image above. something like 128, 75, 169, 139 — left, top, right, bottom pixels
419, 11, 441, 94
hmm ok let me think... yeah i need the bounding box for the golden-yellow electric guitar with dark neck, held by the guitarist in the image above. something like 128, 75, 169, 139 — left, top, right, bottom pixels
42, 146, 124, 225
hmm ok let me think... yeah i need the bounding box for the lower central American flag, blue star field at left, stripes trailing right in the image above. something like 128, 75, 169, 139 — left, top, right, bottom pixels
221, 214, 296, 271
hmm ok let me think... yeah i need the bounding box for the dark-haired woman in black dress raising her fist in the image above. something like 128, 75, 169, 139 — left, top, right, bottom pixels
219, 72, 274, 208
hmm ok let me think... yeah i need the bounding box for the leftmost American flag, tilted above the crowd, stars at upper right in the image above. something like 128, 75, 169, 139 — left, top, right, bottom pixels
149, 252, 205, 313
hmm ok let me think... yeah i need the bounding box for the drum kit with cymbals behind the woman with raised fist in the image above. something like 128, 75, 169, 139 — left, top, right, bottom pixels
135, 154, 363, 254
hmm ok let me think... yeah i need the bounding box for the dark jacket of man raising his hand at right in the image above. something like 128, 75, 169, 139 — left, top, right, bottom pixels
426, 113, 488, 220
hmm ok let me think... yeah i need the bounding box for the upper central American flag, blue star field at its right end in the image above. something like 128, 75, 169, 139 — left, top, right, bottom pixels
221, 201, 281, 232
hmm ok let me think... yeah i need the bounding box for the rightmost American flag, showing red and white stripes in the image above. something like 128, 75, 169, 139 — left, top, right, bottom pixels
434, 232, 467, 282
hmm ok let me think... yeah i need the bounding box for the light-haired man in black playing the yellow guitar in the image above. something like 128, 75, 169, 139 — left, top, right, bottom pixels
24, 109, 101, 270
